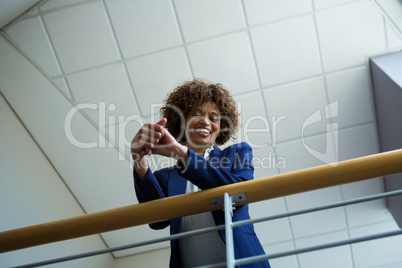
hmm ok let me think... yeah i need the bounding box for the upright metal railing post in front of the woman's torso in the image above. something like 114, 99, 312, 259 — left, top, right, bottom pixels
224, 193, 235, 268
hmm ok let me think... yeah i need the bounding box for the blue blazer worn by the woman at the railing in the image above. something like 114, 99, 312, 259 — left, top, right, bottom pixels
134, 142, 270, 268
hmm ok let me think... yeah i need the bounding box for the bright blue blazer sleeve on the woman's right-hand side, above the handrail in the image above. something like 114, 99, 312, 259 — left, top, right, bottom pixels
179, 142, 254, 190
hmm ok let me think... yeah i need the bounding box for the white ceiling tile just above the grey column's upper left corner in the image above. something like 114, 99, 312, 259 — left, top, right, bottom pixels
316, 1, 385, 72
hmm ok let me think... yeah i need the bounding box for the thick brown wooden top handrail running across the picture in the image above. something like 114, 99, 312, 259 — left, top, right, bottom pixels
0, 150, 402, 253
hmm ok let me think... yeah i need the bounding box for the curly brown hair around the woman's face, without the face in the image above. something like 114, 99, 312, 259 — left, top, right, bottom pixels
160, 79, 240, 145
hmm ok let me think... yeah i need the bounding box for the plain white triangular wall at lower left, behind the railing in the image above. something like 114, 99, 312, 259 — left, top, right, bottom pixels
0, 94, 113, 268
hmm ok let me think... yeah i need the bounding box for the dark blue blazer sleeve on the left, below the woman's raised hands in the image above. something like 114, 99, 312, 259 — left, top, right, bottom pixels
133, 167, 170, 230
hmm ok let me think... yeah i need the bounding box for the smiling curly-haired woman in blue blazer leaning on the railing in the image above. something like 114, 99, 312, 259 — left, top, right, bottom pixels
131, 80, 269, 267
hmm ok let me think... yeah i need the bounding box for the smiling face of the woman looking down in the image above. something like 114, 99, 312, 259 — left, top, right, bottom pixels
185, 101, 221, 155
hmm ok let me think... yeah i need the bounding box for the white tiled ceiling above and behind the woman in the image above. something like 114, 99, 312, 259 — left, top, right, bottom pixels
0, 0, 402, 264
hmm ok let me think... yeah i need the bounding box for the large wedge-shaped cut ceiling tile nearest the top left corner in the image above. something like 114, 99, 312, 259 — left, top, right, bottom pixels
6, 17, 60, 77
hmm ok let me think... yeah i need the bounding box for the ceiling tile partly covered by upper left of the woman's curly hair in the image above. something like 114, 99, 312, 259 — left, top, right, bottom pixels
127, 48, 192, 116
